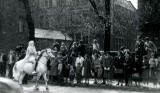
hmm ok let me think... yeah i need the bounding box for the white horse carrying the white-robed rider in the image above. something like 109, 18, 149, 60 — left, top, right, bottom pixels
13, 49, 54, 90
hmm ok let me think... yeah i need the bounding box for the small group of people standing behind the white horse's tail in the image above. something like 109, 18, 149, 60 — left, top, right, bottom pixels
0, 45, 26, 78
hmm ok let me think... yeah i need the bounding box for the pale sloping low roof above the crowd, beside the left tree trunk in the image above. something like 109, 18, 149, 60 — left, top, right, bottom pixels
35, 28, 72, 41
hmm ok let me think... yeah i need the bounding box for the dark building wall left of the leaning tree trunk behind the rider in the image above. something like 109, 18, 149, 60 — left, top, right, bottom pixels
0, 0, 29, 51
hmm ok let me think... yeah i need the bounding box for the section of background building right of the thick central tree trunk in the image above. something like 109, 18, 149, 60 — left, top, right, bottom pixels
111, 0, 138, 51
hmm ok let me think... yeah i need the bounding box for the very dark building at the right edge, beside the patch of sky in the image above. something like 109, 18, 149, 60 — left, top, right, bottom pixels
138, 0, 160, 49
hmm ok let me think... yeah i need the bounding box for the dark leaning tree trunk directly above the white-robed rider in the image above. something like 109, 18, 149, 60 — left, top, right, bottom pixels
22, 0, 35, 40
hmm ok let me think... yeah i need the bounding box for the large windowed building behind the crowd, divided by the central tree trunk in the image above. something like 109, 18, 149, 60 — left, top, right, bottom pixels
30, 0, 137, 50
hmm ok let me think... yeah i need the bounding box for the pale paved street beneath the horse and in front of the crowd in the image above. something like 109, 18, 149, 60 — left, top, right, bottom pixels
23, 84, 159, 93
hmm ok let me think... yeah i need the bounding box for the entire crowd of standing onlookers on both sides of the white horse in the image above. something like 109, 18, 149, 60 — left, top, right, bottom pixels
0, 37, 159, 85
